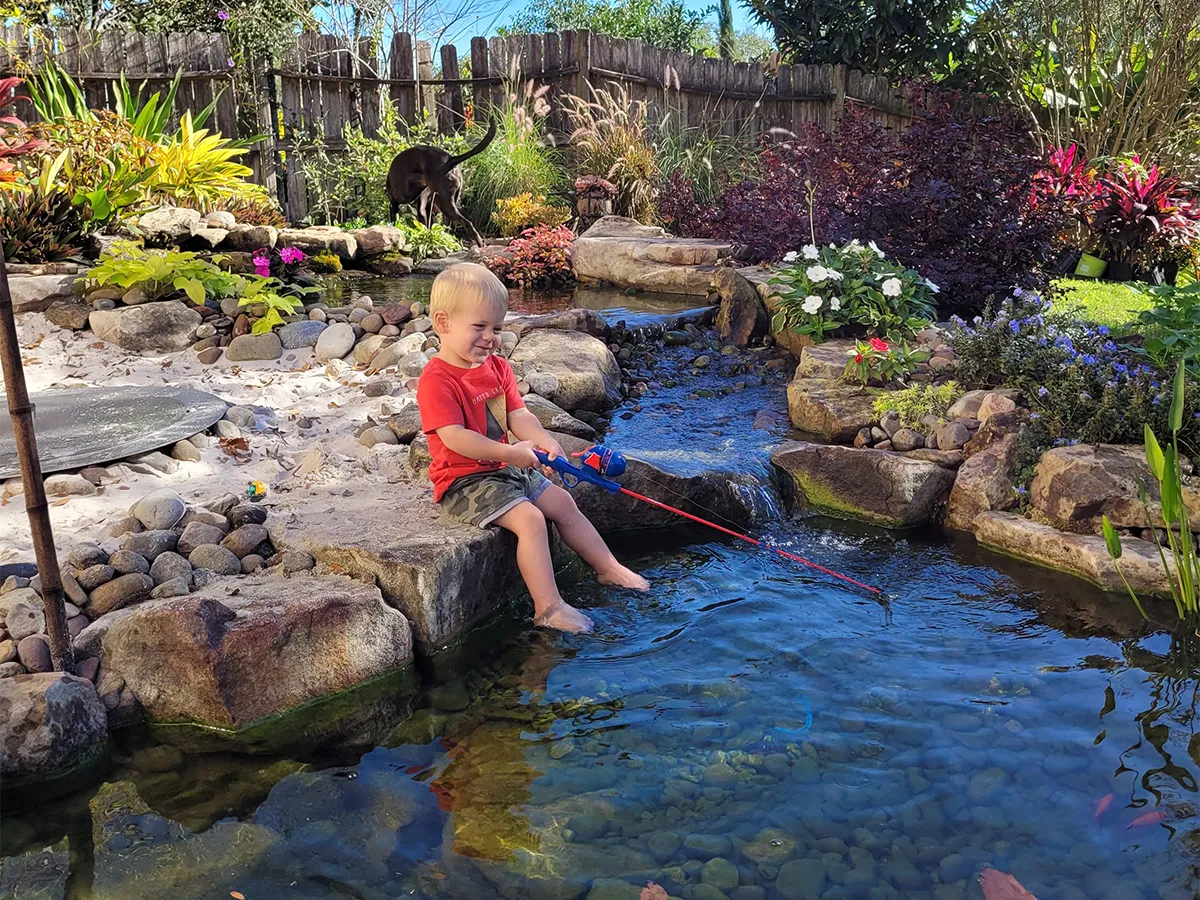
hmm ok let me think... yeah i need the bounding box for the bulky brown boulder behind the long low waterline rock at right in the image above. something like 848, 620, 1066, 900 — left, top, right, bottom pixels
1030, 444, 1200, 534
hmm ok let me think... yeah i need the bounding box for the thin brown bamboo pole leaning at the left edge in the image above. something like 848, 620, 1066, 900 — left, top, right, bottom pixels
0, 246, 74, 674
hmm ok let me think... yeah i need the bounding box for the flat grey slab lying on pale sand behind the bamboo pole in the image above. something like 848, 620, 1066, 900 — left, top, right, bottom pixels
0, 386, 229, 478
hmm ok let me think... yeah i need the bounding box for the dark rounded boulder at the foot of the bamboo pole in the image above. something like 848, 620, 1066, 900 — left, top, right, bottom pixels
0, 672, 108, 787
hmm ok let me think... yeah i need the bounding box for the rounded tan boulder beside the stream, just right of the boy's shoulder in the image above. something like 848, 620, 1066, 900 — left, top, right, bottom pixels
510, 329, 620, 412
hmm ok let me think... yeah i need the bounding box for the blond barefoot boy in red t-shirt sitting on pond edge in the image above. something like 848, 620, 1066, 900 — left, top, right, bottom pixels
416, 263, 649, 632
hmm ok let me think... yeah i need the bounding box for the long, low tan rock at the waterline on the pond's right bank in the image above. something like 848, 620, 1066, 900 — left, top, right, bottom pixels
972, 510, 1171, 596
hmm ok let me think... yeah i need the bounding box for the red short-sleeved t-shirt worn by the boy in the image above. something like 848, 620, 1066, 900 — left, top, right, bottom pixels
416, 355, 524, 500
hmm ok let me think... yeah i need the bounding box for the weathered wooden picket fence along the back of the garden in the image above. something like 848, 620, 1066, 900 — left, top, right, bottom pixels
0, 26, 945, 221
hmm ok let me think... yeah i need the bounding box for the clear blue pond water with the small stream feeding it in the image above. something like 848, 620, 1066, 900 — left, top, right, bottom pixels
0, 278, 1200, 900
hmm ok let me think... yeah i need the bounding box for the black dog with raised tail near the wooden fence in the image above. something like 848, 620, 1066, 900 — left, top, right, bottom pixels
388, 119, 496, 246
